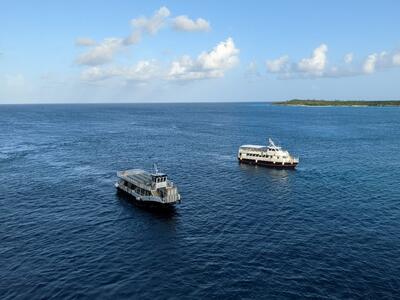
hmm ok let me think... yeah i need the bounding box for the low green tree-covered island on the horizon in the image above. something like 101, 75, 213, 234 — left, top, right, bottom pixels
273, 99, 400, 106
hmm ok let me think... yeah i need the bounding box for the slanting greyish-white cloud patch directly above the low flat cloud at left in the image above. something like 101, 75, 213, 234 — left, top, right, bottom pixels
76, 38, 123, 66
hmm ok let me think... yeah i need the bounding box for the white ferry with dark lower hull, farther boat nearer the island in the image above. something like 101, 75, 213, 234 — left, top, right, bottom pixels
238, 139, 299, 169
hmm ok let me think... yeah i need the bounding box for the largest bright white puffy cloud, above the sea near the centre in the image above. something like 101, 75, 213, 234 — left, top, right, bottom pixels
167, 38, 239, 80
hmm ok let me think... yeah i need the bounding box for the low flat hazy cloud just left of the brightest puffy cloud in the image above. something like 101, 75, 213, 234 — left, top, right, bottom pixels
81, 60, 158, 81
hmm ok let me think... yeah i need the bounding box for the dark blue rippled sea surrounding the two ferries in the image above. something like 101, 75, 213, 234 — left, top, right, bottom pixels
0, 103, 400, 299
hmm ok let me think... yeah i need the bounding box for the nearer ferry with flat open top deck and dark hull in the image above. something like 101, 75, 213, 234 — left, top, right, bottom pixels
115, 167, 181, 207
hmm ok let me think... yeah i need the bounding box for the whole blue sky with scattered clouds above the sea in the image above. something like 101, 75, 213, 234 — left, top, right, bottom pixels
0, 0, 400, 104
